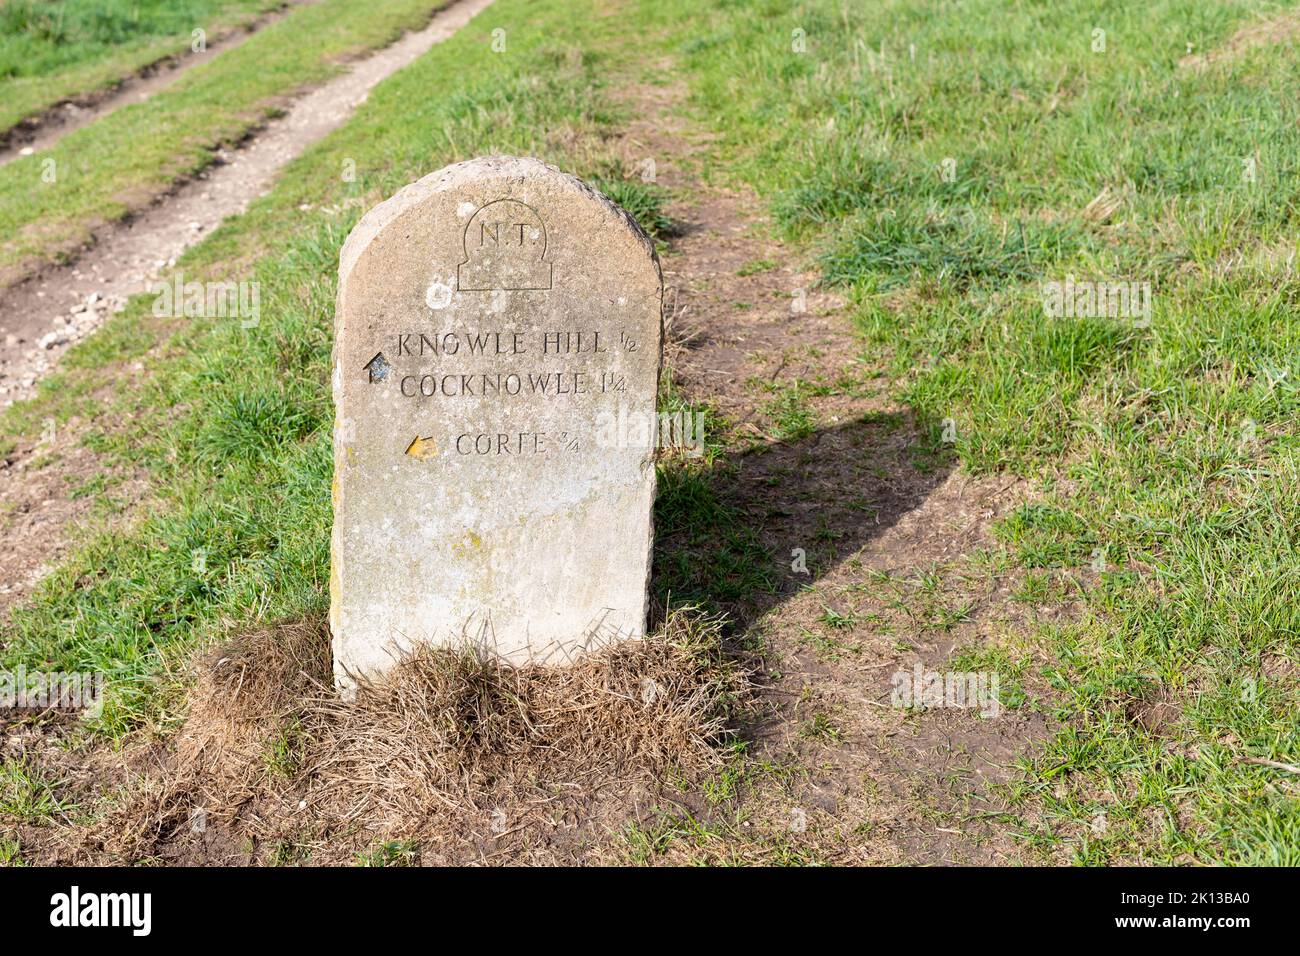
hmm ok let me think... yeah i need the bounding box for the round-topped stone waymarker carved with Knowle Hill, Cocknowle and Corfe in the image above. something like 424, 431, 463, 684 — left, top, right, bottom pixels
330, 156, 663, 691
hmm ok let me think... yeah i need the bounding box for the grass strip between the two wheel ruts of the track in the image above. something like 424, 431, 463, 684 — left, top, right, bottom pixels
0, 0, 457, 278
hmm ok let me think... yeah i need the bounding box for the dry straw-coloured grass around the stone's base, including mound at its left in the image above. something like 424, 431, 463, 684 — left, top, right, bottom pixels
68, 614, 748, 862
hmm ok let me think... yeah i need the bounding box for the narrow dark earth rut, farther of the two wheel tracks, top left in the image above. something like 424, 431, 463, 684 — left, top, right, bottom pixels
0, 0, 315, 166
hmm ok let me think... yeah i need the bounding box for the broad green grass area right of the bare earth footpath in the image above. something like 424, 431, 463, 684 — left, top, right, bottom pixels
657, 0, 1300, 864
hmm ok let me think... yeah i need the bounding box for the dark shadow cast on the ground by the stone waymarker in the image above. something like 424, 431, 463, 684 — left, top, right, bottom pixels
651, 412, 956, 650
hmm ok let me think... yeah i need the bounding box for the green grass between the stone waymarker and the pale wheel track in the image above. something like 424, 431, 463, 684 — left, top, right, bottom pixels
0, 0, 681, 738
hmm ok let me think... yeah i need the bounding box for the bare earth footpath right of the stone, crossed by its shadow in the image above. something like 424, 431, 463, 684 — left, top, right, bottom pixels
603, 78, 1045, 864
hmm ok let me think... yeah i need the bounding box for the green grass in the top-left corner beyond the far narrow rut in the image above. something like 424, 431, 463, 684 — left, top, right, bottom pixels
0, 0, 280, 136
